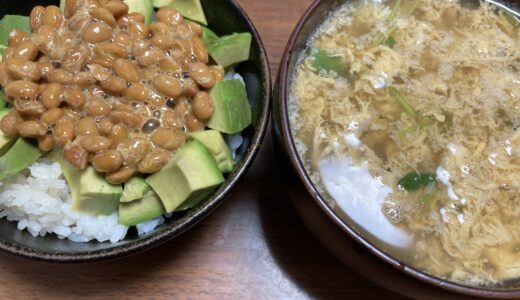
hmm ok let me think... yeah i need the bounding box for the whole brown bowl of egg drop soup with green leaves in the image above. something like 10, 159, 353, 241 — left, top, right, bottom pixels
274, 0, 520, 297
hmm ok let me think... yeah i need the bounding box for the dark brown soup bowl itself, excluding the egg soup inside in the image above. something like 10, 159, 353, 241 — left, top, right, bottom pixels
273, 0, 520, 299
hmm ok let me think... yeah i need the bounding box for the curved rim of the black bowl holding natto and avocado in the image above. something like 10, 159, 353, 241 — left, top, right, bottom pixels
0, 0, 272, 264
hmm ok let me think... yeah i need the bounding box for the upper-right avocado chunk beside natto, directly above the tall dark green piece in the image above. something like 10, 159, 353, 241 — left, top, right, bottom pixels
208, 32, 252, 68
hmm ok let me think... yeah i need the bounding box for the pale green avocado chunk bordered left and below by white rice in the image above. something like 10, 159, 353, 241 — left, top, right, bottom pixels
47, 148, 123, 215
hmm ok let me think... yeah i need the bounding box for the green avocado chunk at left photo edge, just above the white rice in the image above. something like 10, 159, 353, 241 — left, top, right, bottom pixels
0, 138, 43, 180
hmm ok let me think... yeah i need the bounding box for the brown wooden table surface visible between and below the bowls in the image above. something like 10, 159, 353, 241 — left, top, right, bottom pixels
0, 0, 406, 299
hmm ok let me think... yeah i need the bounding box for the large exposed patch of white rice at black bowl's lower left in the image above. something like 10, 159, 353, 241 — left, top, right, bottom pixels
0, 159, 129, 243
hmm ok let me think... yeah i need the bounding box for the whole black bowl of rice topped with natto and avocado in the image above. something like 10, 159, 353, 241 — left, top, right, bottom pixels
0, 0, 270, 263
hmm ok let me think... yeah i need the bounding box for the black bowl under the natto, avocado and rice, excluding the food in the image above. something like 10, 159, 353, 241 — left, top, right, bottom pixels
0, 0, 271, 263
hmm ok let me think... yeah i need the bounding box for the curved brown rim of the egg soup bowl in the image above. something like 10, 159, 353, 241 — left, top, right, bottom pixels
273, 0, 520, 298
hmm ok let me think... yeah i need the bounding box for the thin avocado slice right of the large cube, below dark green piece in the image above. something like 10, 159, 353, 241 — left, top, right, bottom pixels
190, 130, 234, 173
